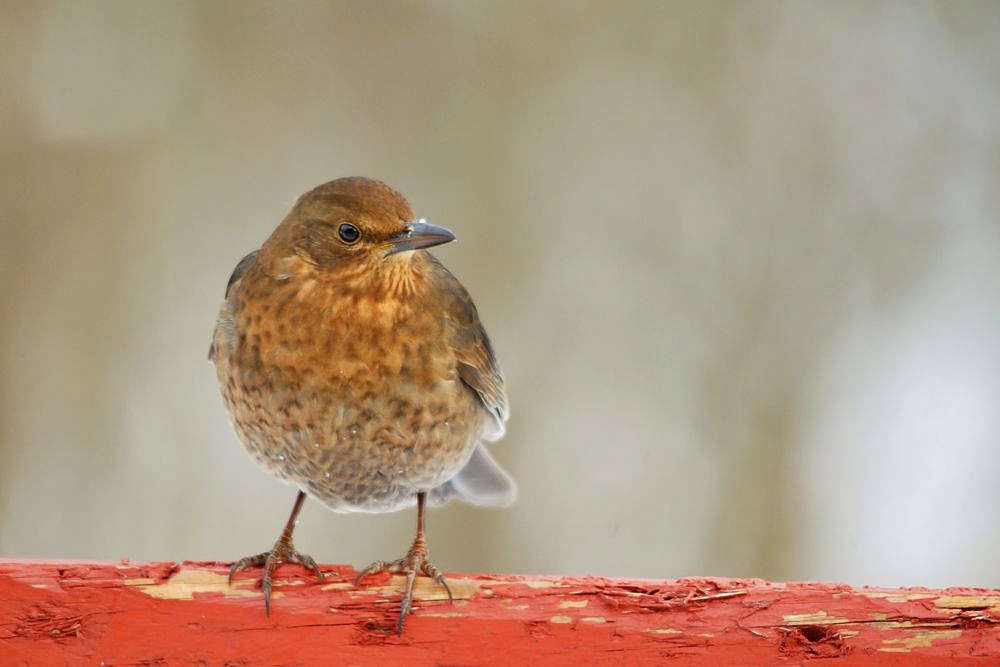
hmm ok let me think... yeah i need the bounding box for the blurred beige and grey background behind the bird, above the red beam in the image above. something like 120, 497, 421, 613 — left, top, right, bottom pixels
0, 0, 1000, 586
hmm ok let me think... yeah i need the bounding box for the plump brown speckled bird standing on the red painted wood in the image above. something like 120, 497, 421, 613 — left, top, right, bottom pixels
209, 177, 516, 633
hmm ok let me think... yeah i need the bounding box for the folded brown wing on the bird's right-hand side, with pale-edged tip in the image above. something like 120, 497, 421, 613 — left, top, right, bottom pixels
432, 257, 510, 441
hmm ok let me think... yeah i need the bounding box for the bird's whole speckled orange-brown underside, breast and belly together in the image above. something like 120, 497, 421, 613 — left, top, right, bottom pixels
214, 264, 486, 512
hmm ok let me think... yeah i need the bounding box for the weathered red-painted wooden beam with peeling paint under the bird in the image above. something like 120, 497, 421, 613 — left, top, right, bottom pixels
0, 560, 1000, 667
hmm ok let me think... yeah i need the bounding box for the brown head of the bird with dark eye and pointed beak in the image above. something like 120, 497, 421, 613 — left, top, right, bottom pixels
269, 177, 455, 269
